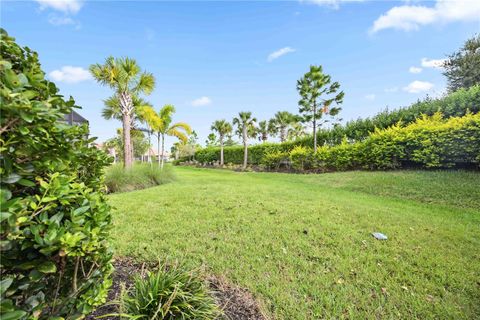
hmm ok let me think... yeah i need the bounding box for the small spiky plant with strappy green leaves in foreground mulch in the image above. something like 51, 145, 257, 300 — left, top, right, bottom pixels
119, 265, 221, 319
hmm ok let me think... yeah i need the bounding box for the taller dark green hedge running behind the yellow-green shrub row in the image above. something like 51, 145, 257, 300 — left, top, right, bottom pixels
195, 86, 480, 165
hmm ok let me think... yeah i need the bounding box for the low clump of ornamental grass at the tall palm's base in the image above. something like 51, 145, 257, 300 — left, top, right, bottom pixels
105, 163, 174, 192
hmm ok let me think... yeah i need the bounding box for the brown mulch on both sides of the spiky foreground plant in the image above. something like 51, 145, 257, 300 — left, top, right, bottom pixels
86, 258, 267, 320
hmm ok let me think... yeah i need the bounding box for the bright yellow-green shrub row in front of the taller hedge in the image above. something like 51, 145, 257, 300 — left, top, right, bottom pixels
197, 113, 480, 171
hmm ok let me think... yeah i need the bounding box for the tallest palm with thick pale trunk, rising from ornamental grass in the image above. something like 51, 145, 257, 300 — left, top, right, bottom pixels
90, 57, 155, 168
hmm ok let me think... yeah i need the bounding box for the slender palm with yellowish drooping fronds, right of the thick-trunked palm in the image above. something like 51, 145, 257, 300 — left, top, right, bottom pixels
150, 104, 192, 169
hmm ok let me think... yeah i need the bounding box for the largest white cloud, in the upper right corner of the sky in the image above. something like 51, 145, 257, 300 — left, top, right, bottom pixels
370, 0, 480, 33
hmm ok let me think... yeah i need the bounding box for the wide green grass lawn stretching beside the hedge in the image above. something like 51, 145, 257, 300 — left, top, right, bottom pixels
110, 167, 480, 319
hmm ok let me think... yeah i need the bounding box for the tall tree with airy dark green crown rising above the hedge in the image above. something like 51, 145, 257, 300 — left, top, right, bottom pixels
297, 66, 345, 151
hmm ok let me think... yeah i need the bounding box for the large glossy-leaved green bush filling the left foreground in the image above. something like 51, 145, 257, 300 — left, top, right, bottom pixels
0, 29, 112, 320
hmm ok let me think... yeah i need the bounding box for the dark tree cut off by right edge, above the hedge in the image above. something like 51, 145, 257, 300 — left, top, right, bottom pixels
443, 34, 480, 92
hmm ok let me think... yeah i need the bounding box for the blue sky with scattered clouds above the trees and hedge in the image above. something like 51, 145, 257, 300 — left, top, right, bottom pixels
1, 0, 480, 150
